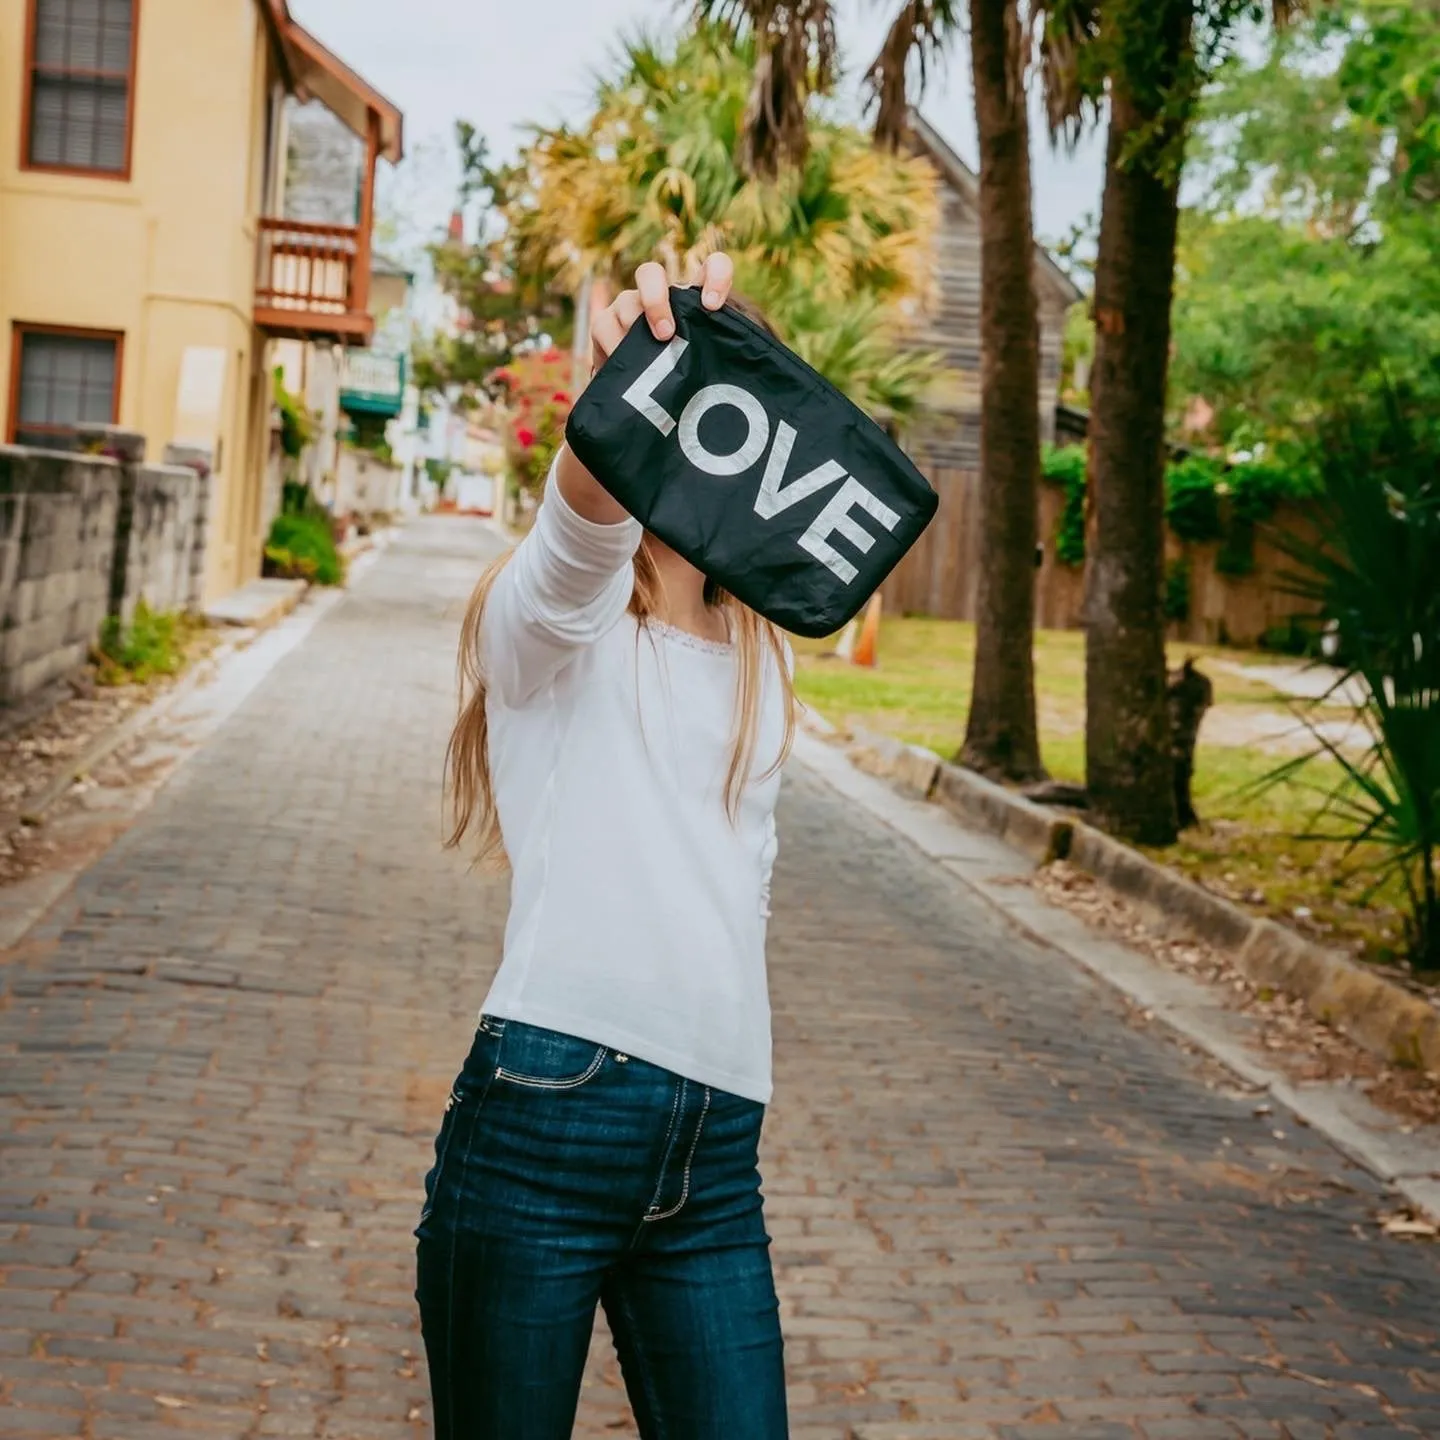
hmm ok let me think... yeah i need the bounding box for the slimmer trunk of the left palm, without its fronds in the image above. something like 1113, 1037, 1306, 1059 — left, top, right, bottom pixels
960, 0, 1045, 780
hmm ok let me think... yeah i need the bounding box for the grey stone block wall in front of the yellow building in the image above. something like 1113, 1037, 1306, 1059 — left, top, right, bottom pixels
0, 445, 209, 704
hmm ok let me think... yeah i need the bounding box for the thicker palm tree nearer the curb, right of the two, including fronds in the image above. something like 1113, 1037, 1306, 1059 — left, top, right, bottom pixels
1038, 0, 1299, 845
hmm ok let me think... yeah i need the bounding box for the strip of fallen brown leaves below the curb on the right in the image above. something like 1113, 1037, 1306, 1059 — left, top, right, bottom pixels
1031, 861, 1440, 1125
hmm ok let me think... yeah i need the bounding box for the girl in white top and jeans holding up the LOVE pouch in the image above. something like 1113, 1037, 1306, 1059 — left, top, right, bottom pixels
416, 255, 793, 1440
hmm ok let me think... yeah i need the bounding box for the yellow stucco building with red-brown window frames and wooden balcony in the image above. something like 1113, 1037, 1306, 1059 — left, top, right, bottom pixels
0, 0, 402, 599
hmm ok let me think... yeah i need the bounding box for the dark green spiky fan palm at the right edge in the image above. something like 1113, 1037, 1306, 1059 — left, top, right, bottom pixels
1263, 397, 1440, 971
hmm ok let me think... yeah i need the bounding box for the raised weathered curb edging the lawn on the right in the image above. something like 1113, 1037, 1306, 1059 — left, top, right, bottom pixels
801, 711, 1440, 1071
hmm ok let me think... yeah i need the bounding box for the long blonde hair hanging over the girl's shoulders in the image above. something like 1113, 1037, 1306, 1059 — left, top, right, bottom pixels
445, 541, 795, 861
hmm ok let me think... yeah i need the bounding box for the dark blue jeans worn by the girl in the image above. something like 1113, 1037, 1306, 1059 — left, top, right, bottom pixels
416, 1017, 786, 1440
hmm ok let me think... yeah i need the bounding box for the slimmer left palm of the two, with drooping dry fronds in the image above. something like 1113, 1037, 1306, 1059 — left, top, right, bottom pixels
697, 0, 1044, 780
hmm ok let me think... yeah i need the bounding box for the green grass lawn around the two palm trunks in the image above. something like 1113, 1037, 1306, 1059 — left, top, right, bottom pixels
795, 618, 1401, 960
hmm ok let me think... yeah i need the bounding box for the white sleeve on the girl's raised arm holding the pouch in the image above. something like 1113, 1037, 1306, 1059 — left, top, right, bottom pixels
480, 465, 642, 706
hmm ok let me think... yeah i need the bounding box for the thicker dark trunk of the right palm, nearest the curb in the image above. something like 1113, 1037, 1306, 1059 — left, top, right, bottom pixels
1086, 14, 1191, 845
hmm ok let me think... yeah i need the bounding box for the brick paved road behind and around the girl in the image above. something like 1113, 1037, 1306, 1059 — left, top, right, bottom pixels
0, 520, 1440, 1440
